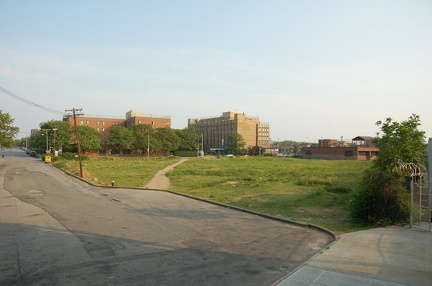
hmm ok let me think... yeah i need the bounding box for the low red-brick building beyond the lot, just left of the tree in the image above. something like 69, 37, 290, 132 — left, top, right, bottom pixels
302, 136, 379, 161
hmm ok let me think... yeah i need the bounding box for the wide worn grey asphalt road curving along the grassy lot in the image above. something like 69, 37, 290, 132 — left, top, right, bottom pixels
0, 149, 332, 286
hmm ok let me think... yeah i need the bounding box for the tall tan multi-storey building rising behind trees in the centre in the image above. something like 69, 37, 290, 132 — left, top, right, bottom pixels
188, 112, 270, 153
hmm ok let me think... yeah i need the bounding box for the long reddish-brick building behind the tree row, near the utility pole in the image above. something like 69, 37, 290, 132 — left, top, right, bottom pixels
63, 110, 171, 152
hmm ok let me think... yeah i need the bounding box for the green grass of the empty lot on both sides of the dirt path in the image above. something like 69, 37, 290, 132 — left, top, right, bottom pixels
56, 157, 370, 233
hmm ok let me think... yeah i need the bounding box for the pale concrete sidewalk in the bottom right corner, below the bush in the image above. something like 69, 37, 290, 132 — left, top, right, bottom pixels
277, 227, 432, 286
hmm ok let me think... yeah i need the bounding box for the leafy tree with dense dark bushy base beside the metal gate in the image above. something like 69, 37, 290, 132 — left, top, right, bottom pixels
351, 114, 426, 225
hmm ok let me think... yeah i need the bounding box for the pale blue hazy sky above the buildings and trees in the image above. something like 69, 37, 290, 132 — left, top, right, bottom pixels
0, 0, 432, 142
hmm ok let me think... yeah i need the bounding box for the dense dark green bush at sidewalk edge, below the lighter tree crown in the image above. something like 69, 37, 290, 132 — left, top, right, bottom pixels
351, 169, 410, 226
